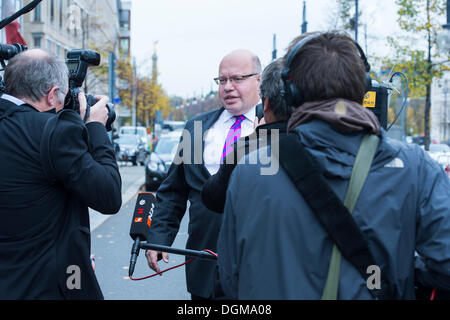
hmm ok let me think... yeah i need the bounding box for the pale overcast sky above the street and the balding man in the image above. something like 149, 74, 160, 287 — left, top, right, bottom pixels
131, 0, 398, 98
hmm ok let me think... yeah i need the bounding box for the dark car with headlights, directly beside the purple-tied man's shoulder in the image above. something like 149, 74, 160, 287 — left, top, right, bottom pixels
145, 131, 182, 191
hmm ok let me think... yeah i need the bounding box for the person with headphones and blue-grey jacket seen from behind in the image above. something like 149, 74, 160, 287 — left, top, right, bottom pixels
217, 31, 450, 300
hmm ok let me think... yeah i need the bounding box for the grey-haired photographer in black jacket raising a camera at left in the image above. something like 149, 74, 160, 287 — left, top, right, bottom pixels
0, 49, 122, 299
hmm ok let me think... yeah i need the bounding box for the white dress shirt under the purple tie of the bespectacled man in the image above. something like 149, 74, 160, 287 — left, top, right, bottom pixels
203, 106, 256, 175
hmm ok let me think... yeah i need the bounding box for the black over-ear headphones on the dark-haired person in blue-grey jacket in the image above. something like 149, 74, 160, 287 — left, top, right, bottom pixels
281, 33, 372, 107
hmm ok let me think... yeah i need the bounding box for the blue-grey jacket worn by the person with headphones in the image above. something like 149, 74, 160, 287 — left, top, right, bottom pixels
218, 120, 450, 299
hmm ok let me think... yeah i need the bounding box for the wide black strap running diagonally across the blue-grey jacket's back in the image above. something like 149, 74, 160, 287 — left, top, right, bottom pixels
279, 134, 393, 300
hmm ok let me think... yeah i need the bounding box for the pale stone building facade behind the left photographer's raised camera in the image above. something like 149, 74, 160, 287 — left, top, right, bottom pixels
14, 0, 131, 95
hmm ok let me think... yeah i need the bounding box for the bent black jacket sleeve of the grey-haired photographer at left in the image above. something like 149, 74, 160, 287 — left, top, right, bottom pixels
50, 114, 122, 214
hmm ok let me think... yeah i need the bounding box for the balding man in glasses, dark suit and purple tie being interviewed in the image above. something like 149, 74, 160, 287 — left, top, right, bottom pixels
146, 50, 261, 299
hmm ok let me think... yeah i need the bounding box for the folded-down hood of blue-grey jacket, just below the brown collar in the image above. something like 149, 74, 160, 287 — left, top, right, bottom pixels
292, 120, 400, 179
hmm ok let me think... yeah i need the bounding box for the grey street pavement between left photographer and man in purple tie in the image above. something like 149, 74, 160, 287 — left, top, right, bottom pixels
90, 165, 190, 300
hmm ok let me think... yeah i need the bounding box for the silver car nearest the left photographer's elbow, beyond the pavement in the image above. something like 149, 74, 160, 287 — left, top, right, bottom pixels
114, 134, 147, 166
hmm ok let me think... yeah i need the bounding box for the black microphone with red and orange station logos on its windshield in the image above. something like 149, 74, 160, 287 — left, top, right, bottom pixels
128, 192, 156, 278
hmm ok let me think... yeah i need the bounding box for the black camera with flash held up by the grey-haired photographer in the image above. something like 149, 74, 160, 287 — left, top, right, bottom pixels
64, 49, 116, 131
